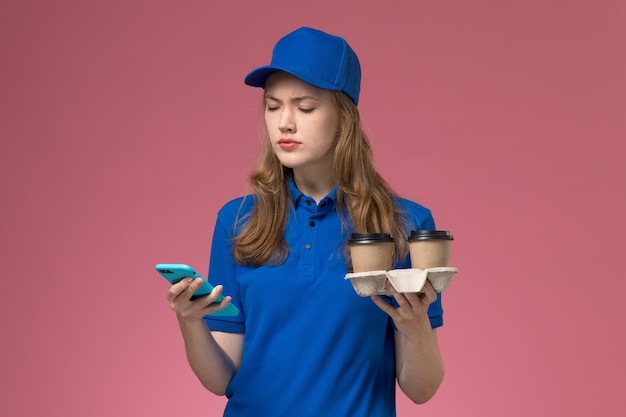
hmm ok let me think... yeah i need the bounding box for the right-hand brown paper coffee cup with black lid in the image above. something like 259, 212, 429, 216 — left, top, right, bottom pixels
408, 230, 454, 270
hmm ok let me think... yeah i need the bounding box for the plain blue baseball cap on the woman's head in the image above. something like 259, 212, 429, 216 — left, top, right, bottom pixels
245, 27, 361, 104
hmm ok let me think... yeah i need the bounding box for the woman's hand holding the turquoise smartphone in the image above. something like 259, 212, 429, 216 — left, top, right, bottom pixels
167, 277, 232, 321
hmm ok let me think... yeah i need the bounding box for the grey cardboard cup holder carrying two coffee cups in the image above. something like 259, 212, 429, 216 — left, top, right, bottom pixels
345, 267, 459, 297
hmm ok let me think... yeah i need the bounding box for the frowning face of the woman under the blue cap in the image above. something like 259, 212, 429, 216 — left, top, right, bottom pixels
265, 71, 339, 175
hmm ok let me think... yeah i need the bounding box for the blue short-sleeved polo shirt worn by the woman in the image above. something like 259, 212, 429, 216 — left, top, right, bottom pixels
205, 181, 443, 417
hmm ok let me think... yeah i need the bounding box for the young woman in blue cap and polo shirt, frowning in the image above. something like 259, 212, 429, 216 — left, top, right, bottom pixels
167, 28, 444, 417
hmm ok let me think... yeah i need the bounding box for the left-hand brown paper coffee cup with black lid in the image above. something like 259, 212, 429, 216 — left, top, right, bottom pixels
348, 233, 393, 272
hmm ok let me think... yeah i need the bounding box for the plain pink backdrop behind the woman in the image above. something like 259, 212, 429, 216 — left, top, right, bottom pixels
0, 0, 626, 417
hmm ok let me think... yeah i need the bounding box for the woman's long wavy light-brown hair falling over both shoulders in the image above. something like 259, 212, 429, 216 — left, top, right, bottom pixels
233, 92, 408, 266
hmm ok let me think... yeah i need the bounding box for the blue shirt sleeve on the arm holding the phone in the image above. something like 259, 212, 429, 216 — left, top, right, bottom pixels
204, 201, 246, 333
